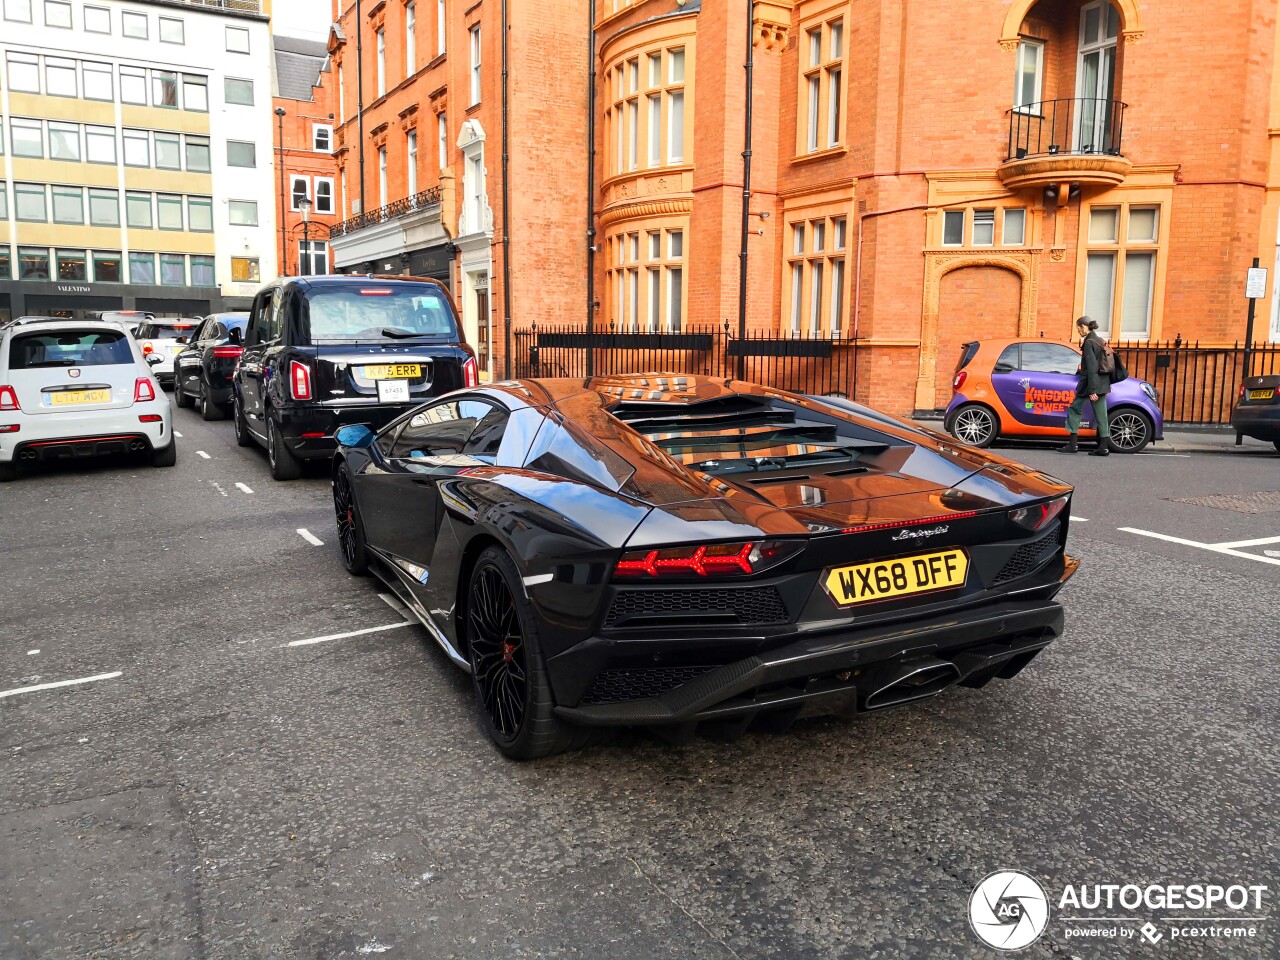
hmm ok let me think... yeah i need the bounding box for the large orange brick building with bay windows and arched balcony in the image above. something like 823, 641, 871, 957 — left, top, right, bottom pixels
309, 0, 1280, 412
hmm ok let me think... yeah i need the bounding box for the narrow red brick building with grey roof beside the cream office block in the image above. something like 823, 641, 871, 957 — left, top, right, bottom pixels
271, 36, 338, 276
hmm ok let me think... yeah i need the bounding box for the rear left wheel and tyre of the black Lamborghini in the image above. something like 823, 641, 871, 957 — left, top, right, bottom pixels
463, 547, 594, 760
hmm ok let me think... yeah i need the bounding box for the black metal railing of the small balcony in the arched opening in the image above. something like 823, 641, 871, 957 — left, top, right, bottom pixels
1007, 97, 1128, 160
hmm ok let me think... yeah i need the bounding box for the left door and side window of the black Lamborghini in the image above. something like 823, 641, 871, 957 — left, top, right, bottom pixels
357, 397, 498, 585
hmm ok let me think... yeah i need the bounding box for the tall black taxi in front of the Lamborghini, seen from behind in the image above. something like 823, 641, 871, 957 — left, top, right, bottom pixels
232, 276, 479, 480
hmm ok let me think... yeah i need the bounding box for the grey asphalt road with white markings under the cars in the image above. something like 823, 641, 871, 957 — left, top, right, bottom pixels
0, 410, 1280, 960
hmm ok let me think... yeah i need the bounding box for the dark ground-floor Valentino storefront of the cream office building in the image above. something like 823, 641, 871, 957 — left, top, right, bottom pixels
0, 280, 225, 323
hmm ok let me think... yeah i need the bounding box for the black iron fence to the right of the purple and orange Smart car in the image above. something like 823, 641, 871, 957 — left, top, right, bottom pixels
1116, 337, 1280, 424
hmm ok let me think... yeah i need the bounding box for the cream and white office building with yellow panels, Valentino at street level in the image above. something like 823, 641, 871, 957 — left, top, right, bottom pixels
0, 0, 276, 321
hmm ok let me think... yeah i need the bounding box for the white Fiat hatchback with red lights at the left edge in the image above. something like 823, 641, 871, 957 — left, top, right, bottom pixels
0, 320, 178, 481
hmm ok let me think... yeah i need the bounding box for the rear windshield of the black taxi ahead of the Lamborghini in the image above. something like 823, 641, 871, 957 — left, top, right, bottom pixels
301, 280, 460, 343
